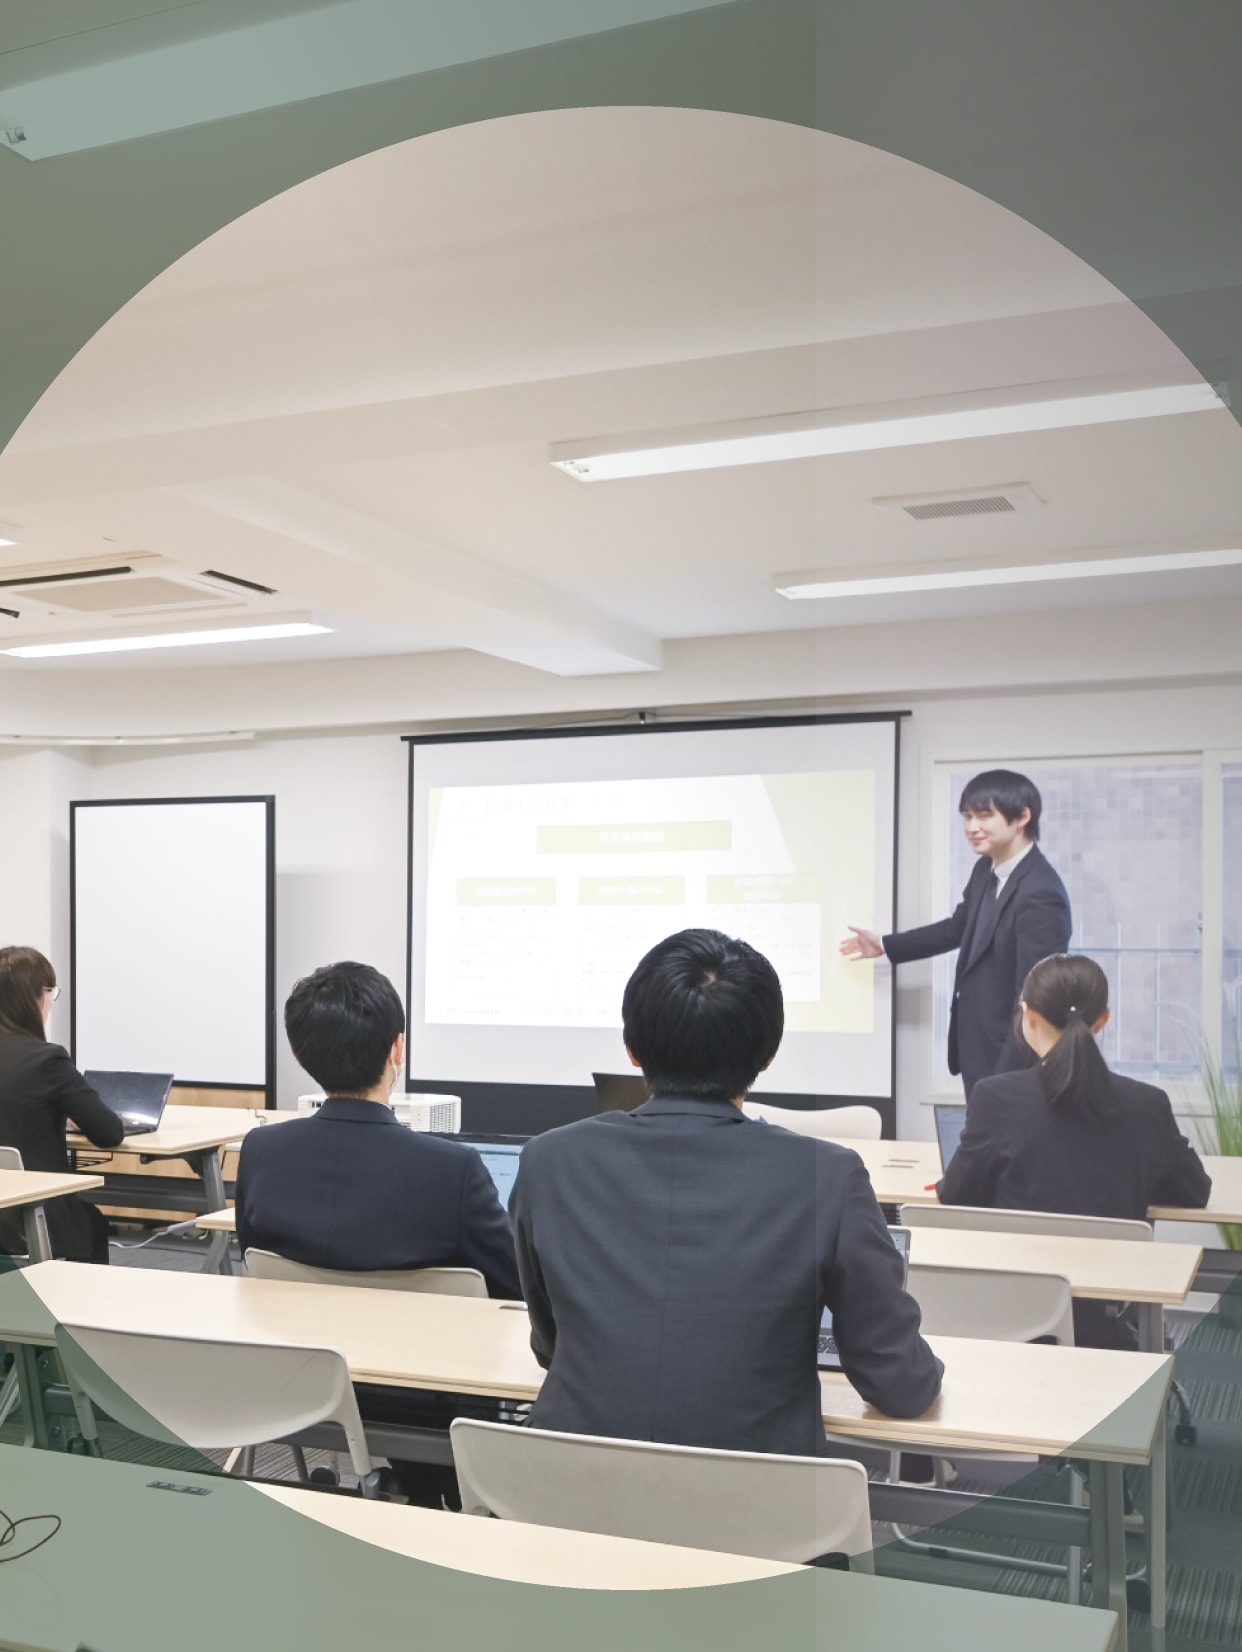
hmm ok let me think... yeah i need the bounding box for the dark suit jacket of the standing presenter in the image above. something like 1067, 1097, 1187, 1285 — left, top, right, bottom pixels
884, 846, 1074, 1095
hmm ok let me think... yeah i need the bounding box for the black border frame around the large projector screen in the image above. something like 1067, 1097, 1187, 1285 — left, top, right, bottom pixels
401, 710, 912, 1140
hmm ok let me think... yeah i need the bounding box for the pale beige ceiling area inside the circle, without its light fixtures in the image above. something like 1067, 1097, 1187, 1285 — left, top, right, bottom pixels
0, 107, 1242, 677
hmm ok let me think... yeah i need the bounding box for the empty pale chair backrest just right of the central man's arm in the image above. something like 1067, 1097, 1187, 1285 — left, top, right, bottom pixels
905, 1262, 1074, 1348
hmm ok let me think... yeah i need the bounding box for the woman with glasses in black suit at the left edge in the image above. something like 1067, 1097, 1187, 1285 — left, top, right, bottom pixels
0, 947, 124, 1262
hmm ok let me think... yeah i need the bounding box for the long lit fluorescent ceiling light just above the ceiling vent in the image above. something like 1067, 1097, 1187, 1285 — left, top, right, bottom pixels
548, 380, 1224, 482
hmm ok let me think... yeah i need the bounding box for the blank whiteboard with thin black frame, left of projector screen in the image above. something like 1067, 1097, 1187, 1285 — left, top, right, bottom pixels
69, 798, 276, 1089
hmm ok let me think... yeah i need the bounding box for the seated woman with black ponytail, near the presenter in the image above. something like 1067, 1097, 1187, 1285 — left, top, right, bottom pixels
940, 953, 1212, 1346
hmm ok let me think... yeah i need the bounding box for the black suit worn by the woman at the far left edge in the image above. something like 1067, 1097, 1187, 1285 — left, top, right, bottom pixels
0, 1033, 126, 1262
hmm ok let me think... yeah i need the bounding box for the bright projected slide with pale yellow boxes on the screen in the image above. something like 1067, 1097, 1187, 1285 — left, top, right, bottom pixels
426, 770, 875, 1033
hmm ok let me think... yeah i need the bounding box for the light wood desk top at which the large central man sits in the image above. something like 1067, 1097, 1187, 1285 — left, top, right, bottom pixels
0, 1262, 1173, 1462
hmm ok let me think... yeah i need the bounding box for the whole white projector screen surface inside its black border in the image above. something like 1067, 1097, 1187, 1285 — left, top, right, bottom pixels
408, 719, 897, 1097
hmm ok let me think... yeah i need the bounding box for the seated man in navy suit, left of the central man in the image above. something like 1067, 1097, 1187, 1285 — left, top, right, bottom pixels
236, 963, 522, 1507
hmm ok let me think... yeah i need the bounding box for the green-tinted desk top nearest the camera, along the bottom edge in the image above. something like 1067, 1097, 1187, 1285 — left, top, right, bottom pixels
0, 1447, 1116, 1652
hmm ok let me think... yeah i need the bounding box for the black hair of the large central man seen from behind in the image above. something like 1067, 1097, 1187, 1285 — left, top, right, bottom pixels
621, 930, 785, 1102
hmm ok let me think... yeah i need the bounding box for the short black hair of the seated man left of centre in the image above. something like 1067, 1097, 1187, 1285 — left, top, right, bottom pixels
284, 963, 405, 1095
